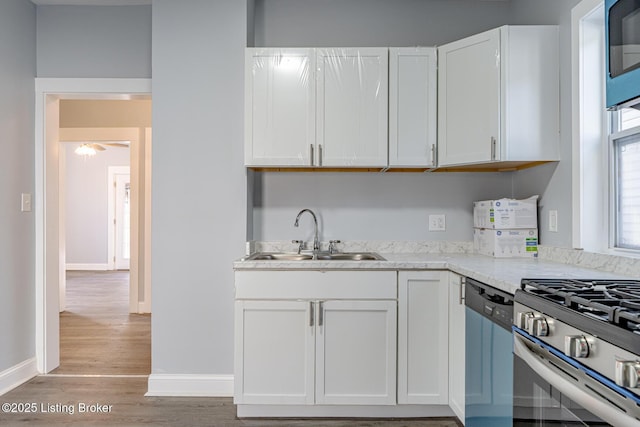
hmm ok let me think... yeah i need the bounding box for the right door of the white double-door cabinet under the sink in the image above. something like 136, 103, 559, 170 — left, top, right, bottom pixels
316, 301, 396, 405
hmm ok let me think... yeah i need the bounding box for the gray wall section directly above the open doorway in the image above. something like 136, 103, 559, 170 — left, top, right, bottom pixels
37, 6, 151, 78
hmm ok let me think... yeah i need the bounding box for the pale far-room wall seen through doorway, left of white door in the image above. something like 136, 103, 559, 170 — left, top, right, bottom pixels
63, 143, 130, 264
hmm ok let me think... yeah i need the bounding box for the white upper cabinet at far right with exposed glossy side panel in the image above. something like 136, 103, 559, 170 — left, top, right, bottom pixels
438, 26, 560, 166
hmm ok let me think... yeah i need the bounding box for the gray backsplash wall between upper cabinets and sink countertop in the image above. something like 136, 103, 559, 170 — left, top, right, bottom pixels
253, 172, 512, 241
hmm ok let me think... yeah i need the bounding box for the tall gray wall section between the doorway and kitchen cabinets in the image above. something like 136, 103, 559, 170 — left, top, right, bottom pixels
151, 0, 247, 374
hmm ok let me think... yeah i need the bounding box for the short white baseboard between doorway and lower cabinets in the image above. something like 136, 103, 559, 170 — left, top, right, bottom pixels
145, 374, 233, 397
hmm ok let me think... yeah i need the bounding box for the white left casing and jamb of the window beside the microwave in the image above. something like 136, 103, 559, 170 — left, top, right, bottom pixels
571, 0, 609, 253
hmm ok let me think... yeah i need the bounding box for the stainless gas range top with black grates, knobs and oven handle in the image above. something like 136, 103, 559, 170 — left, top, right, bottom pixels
513, 279, 640, 425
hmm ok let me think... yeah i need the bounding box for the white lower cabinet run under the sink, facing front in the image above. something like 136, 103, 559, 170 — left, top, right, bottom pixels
234, 270, 464, 419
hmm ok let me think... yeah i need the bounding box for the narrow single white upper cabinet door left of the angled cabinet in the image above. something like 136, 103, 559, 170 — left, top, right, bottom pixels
389, 47, 437, 167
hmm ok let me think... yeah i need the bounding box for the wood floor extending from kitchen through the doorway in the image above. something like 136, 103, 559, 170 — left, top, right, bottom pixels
0, 272, 461, 427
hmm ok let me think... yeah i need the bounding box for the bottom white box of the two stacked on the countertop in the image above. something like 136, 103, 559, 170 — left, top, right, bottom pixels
473, 228, 538, 258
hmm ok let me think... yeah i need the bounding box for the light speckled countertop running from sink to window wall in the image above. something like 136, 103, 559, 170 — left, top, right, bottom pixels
233, 252, 637, 293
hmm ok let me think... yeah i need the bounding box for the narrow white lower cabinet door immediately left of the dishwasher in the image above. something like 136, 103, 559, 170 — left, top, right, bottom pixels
449, 273, 465, 423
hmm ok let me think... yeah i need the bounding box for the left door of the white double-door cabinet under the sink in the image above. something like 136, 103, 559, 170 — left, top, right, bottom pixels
234, 301, 315, 404
